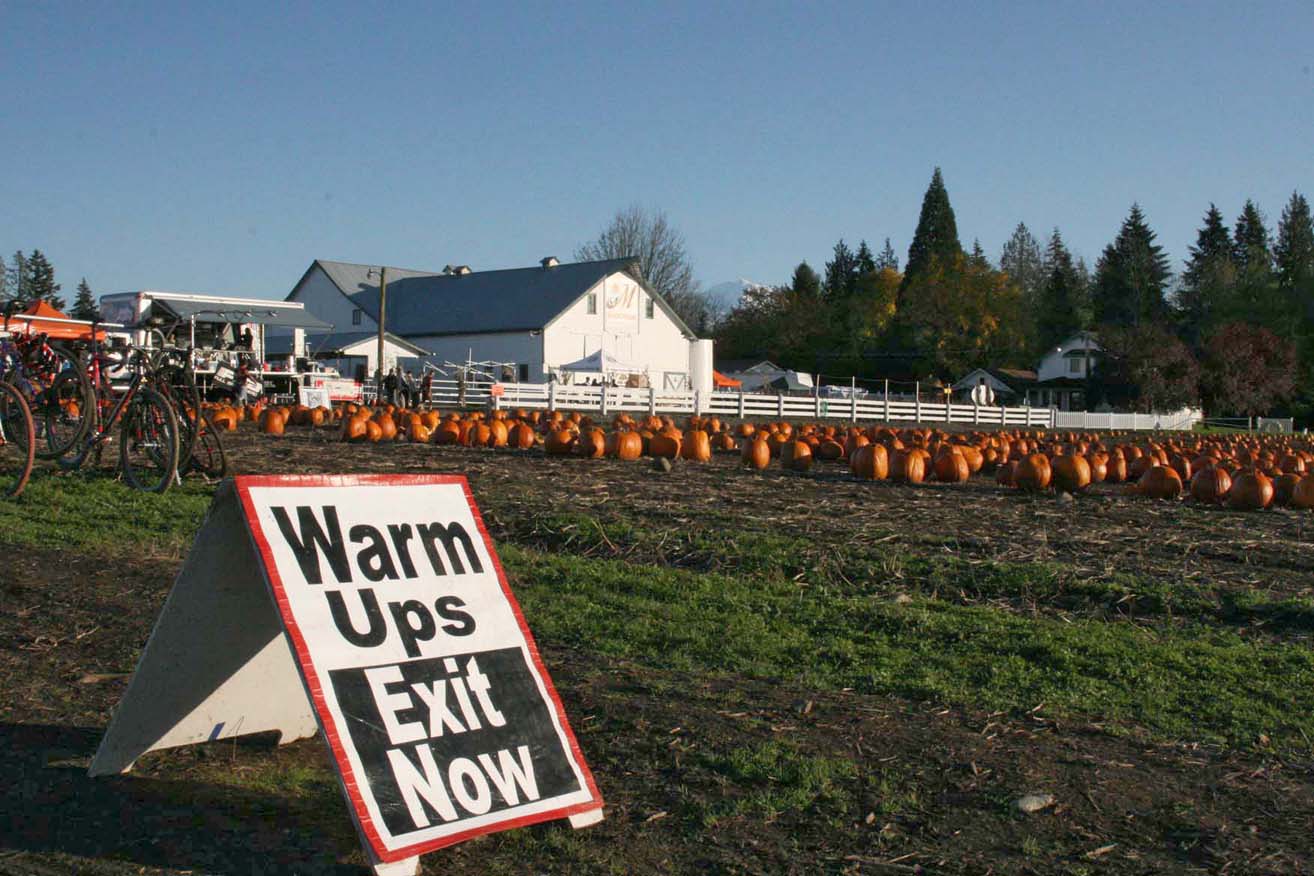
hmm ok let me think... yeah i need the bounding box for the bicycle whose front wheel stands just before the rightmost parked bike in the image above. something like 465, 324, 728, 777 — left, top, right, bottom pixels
59, 341, 179, 493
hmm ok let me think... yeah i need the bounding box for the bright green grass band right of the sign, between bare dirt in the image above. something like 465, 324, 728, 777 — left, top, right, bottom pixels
502, 545, 1314, 747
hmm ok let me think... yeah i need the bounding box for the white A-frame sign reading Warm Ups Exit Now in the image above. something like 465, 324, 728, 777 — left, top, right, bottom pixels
91, 475, 602, 873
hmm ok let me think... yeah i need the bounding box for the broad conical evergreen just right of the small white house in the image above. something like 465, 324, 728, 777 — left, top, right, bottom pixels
1092, 204, 1172, 326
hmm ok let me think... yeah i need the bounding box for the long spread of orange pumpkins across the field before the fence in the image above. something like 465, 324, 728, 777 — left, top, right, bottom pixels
210, 403, 1314, 510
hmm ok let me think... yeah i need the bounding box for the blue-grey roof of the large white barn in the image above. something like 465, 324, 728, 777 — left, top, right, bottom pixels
298, 257, 694, 336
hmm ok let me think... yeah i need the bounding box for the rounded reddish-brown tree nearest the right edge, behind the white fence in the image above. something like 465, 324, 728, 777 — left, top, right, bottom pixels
1201, 322, 1298, 416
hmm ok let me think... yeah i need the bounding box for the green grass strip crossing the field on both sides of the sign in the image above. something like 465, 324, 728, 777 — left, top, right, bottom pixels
10, 475, 1314, 750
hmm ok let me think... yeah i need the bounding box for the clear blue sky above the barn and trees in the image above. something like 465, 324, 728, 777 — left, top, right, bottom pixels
0, 0, 1314, 297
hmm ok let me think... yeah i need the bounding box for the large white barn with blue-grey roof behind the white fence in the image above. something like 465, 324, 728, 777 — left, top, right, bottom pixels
288, 257, 711, 390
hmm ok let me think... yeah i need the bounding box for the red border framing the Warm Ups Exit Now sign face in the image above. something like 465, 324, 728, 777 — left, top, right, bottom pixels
234, 474, 603, 862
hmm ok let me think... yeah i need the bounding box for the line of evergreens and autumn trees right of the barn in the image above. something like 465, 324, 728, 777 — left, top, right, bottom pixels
712, 168, 1314, 419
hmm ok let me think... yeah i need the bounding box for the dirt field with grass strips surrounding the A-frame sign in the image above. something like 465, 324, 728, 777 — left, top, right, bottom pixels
0, 429, 1314, 873
